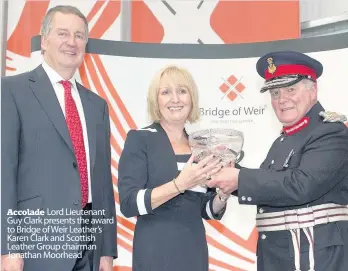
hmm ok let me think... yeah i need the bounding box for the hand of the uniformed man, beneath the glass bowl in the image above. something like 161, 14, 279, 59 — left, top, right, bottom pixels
206, 167, 239, 194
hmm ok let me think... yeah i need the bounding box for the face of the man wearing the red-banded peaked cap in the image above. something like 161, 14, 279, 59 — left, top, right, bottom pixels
270, 80, 317, 126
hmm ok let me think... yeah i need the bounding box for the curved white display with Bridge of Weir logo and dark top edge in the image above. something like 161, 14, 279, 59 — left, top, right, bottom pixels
24, 34, 348, 271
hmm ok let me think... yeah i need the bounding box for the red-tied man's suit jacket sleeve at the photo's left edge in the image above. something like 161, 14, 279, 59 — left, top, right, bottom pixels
1, 79, 20, 254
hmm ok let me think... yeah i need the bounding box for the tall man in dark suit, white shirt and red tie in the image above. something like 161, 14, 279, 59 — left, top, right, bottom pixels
1, 6, 117, 271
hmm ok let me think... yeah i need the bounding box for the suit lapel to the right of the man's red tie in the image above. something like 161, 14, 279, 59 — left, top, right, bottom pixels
76, 83, 97, 175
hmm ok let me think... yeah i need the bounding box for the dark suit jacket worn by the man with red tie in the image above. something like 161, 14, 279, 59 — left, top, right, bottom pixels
1, 65, 117, 271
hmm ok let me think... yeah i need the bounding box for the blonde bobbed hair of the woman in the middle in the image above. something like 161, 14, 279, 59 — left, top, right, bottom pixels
147, 65, 200, 123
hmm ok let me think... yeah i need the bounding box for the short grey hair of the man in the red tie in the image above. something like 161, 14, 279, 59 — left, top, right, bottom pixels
40, 5, 88, 53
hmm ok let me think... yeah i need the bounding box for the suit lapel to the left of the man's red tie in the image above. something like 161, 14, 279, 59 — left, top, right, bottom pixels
29, 65, 74, 153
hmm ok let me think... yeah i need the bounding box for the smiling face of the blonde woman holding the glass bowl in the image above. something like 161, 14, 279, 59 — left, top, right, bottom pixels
157, 75, 192, 124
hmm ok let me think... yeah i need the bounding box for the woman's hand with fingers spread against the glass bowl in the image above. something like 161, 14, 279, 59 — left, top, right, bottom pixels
175, 155, 222, 191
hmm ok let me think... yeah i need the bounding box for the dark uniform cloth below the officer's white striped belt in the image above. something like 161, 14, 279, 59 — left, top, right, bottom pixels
257, 221, 348, 271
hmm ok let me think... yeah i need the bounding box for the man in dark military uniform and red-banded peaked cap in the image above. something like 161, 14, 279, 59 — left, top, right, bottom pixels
208, 51, 348, 271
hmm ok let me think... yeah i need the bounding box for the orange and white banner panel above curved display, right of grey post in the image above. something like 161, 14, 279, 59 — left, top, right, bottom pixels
130, 0, 301, 44
